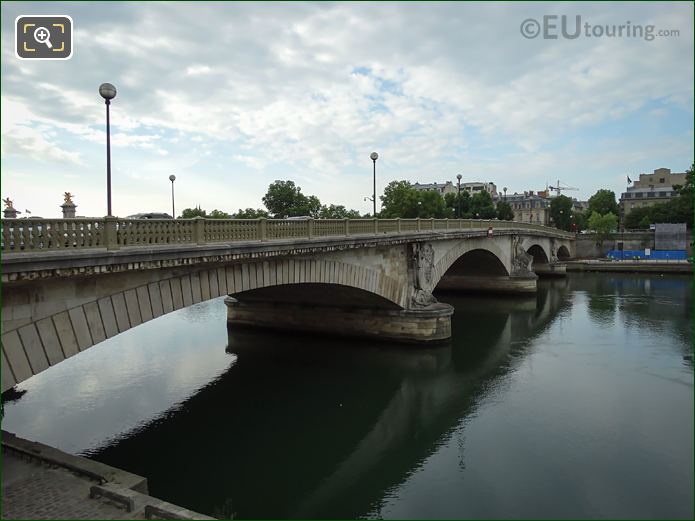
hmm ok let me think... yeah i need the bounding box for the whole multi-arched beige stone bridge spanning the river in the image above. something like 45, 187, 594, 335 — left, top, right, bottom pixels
0, 218, 574, 391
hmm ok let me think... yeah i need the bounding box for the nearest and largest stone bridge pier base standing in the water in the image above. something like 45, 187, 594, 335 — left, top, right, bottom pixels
224, 297, 454, 344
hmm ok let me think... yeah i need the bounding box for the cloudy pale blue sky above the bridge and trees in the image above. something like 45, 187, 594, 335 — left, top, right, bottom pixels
1, 2, 693, 217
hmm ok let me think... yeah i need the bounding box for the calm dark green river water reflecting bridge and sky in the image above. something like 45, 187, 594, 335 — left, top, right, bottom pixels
2, 274, 693, 519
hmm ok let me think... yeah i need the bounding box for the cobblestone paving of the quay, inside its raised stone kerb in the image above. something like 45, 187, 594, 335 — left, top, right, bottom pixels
1, 451, 144, 519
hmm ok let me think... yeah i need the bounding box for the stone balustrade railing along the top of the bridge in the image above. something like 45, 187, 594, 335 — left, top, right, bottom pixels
0, 217, 574, 253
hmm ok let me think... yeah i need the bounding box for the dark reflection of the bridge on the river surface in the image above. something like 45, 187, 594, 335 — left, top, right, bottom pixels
89, 279, 569, 518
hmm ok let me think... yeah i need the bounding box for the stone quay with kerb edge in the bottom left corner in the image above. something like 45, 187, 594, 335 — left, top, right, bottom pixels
1, 431, 214, 519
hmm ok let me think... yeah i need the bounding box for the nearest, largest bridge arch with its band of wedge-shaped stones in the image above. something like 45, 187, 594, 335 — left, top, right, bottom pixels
0, 258, 405, 392
